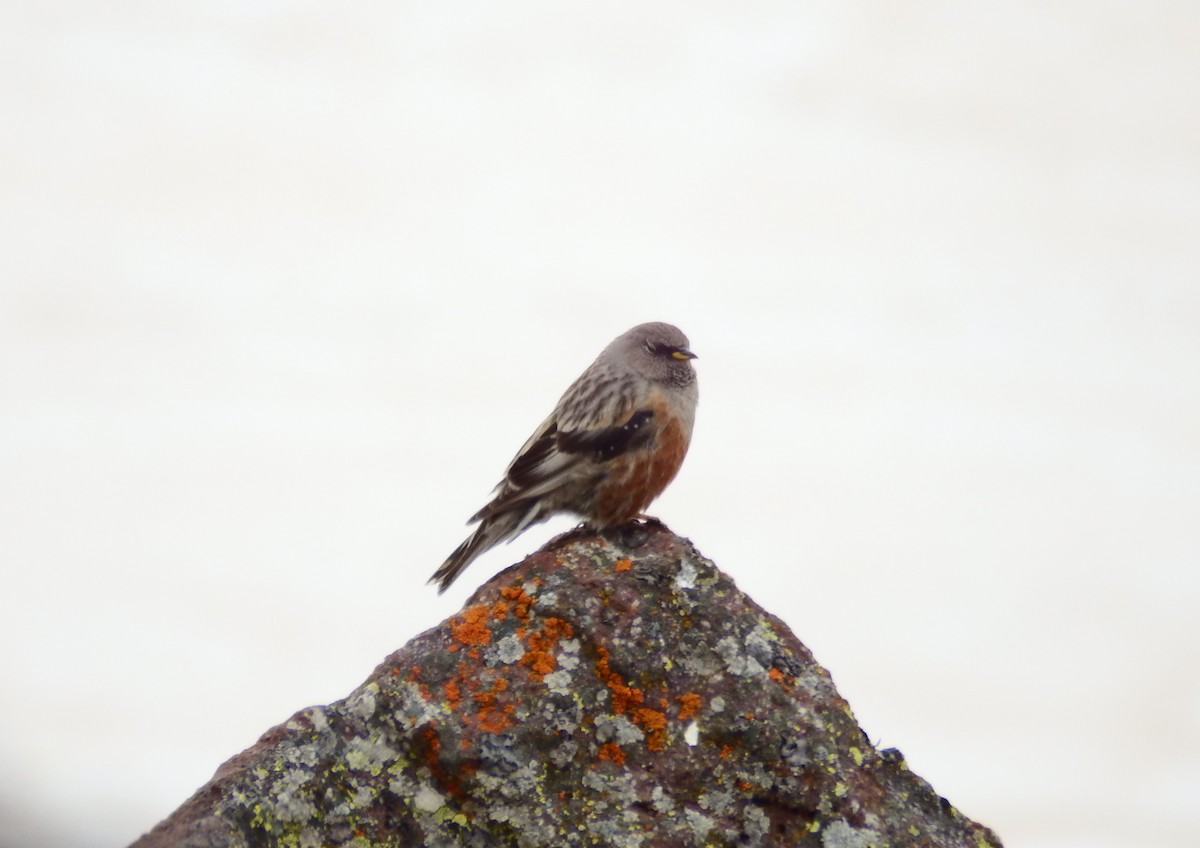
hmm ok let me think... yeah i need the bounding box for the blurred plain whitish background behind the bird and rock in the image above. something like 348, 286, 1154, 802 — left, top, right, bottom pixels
0, 0, 1200, 848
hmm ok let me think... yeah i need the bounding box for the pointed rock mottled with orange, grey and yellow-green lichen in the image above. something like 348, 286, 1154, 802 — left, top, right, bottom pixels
136, 524, 1000, 848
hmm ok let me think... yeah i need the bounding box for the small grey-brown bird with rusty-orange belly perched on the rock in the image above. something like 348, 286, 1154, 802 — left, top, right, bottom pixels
428, 321, 700, 595
